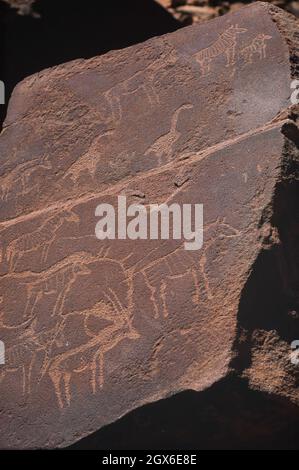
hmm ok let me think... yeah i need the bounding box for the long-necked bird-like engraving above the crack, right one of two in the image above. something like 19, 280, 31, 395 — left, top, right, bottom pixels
145, 104, 193, 164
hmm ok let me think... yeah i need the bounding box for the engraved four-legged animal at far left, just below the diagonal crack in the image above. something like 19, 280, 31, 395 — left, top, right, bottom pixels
6, 210, 80, 271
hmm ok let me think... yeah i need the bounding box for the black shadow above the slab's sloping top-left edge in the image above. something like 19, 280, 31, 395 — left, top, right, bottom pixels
0, 0, 181, 124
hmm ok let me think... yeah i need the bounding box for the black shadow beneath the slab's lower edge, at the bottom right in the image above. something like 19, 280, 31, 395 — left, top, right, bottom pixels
69, 377, 299, 450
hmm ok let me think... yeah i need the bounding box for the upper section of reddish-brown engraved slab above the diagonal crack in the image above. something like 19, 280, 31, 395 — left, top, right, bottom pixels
0, 3, 295, 220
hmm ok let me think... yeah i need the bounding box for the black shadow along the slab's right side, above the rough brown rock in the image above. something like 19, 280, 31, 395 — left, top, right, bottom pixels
232, 125, 299, 374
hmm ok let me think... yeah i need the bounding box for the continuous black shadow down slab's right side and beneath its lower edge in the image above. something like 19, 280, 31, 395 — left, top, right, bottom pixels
67, 126, 299, 450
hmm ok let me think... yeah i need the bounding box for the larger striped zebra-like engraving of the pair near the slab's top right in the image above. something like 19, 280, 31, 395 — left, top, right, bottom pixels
194, 25, 247, 76
